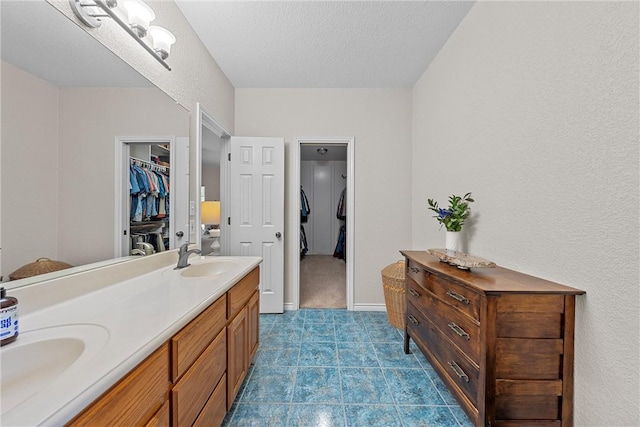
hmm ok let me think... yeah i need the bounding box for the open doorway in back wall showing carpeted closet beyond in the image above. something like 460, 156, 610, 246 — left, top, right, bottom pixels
294, 138, 354, 310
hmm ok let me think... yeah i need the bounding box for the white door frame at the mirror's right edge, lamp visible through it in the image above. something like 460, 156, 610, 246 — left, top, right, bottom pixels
198, 102, 231, 255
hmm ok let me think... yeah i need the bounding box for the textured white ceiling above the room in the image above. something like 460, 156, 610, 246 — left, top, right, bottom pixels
176, 0, 473, 88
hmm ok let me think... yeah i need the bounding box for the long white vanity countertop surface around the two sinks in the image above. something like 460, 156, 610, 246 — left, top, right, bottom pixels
0, 256, 262, 426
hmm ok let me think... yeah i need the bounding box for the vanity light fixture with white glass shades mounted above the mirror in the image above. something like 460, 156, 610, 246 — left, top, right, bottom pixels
69, 0, 176, 71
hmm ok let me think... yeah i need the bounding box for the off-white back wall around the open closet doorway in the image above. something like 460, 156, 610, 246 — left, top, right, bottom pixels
236, 89, 411, 305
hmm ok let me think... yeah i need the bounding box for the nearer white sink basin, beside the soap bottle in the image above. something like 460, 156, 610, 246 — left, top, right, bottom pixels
0, 324, 109, 414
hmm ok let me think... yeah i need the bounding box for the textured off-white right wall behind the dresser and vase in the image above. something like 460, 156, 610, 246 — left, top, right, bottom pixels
412, 2, 640, 426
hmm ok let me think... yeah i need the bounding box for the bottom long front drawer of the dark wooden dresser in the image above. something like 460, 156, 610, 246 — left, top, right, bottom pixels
407, 303, 480, 407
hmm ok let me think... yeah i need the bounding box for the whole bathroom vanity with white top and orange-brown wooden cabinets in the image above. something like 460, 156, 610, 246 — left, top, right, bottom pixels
0, 252, 261, 426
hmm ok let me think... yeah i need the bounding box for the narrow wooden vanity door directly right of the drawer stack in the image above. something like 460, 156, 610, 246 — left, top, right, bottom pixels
227, 306, 249, 410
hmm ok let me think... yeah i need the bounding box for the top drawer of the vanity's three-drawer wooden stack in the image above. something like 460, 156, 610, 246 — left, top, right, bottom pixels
171, 295, 227, 382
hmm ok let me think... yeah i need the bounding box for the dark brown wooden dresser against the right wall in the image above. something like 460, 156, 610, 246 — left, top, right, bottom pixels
400, 251, 584, 427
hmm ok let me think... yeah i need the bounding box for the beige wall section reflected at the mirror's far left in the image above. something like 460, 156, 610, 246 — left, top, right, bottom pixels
0, 61, 58, 280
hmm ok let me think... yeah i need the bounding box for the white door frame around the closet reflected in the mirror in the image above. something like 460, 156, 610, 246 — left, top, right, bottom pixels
113, 136, 176, 258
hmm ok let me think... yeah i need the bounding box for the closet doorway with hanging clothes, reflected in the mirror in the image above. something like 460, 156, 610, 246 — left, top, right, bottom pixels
114, 136, 189, 257
